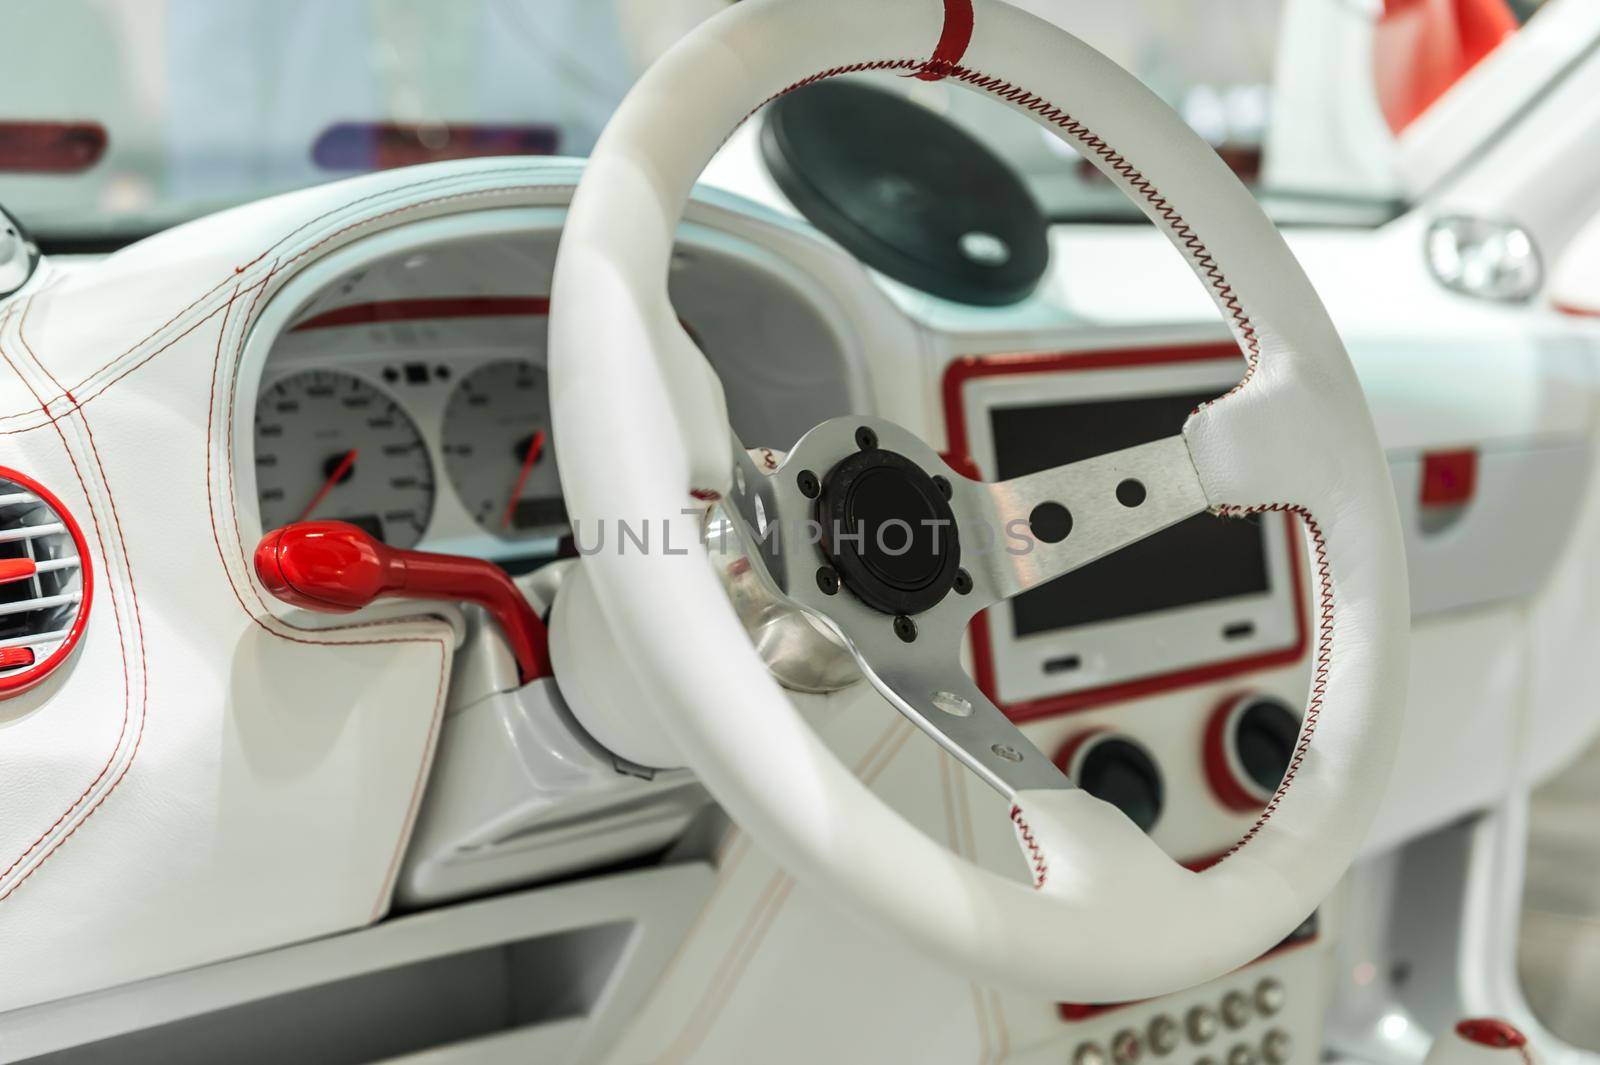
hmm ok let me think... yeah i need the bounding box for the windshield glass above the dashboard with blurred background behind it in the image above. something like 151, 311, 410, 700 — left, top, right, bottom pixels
0, 0, 1548, 249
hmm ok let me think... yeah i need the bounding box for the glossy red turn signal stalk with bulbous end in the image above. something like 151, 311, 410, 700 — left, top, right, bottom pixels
256, 521, 550, 684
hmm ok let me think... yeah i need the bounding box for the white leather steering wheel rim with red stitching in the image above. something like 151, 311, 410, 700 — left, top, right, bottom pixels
550, 0, 1410, 1001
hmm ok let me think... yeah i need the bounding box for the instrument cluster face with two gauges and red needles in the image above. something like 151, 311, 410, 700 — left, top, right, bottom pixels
254, 302, 568, 560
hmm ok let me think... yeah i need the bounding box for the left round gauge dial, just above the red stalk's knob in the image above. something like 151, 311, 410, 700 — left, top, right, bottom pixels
256, 369, 434, 547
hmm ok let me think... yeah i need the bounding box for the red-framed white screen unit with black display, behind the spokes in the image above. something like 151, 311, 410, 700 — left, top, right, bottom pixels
944, 344, 1306, 721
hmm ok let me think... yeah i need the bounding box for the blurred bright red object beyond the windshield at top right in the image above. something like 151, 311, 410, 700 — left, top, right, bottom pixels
1373, 0, 1517, 133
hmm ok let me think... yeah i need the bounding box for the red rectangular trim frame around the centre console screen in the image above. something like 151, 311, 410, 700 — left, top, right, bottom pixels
942, 342, 1310, 721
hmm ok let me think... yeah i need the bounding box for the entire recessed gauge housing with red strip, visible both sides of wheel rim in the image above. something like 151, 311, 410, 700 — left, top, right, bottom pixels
242, 209, 859, 572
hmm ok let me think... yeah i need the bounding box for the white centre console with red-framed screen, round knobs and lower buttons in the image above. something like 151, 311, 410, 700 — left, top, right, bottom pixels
942, 342, 1338, 1065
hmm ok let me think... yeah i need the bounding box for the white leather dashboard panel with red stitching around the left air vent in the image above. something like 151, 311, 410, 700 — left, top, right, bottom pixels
0, 163, 595, 1011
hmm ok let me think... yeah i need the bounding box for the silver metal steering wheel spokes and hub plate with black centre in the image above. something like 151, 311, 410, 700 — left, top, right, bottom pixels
723, 417, 1206, 798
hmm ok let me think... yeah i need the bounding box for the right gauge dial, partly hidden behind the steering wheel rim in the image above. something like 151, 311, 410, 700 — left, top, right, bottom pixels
445, 360, 566, 539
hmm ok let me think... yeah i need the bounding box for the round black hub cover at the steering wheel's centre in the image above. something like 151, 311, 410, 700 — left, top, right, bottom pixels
816, 448, 962, 614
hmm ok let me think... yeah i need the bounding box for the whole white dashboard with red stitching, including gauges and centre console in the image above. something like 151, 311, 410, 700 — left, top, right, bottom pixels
0, 141, 1600, 1065
